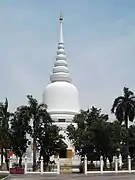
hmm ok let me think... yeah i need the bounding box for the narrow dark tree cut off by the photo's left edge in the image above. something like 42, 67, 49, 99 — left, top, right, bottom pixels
0, 98, 12, 170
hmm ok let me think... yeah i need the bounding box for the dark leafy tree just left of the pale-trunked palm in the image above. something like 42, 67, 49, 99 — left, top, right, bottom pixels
10, 106, 30, 167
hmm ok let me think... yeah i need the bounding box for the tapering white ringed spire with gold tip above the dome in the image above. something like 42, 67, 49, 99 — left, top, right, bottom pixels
50, 12, 71, 82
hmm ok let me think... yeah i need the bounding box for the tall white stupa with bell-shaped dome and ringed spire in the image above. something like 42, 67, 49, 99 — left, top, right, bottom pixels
43, 13, 80, 154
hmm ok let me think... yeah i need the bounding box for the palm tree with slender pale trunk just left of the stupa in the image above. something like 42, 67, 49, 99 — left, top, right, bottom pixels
27, 95, 52, 171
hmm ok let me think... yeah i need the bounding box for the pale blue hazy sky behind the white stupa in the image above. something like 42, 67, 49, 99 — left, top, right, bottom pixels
0, 0, 135, 118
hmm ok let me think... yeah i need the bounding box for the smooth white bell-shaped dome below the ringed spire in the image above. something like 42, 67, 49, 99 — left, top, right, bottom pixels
43, 81, 79, 115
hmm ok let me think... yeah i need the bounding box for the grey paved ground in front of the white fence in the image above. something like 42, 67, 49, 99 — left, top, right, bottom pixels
10, 174, 135, 180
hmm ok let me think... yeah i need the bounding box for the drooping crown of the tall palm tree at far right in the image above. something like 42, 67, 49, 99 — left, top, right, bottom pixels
111, 87, 135, 129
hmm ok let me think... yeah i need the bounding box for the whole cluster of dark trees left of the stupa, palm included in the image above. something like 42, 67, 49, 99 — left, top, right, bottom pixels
0, 95, 63, 170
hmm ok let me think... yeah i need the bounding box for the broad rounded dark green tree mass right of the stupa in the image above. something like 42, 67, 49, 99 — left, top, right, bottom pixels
67, 107, 131, 166
